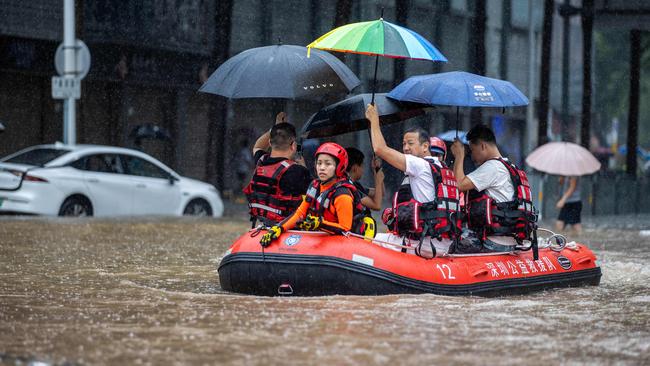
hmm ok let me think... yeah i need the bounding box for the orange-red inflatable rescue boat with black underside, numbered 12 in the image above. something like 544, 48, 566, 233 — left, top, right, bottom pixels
219, 229, 601, 296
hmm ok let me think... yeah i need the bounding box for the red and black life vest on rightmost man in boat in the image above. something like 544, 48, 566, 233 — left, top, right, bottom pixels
467, 158, 537, 244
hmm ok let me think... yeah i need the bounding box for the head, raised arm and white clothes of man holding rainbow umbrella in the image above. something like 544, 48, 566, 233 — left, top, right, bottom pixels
366, 105, 452, 256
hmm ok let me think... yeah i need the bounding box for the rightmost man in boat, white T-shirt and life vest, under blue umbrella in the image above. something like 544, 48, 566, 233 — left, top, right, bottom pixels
451, 125, 537, 253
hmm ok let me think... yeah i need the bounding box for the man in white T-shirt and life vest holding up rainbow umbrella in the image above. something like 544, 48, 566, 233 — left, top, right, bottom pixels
366, 105, 460, 258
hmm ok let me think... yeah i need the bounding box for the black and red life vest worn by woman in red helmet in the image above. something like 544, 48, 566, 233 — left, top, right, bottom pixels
305, 178, 372, 235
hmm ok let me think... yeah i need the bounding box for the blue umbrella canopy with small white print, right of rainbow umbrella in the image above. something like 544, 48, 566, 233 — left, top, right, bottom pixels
388, 71, 528, 107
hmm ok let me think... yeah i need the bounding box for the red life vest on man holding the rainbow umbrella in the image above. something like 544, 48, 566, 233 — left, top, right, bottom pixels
392, 158, 461, 239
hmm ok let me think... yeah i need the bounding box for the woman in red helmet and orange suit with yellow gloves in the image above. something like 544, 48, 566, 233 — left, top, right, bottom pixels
260, 142, 354, 247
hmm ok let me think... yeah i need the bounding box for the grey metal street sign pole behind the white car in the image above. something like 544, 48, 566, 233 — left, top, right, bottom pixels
63, 0, 77, 145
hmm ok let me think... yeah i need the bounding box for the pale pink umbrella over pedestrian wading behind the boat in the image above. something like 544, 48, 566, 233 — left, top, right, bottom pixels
526, 142, 600, 177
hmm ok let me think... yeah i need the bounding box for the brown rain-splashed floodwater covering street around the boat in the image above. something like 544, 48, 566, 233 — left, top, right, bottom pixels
0, 218, 650, 365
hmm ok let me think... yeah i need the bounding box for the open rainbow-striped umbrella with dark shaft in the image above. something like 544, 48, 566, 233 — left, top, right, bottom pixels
307, 18, 447, 102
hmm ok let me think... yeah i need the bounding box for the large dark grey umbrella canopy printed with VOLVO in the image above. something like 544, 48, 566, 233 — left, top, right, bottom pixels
199, 45, 361, 99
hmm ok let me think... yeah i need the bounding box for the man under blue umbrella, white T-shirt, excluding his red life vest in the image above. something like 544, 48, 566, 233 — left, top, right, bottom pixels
451, 125, 517, 251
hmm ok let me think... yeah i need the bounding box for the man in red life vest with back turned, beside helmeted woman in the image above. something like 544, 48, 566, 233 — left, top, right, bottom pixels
244, 112, 311, 227
